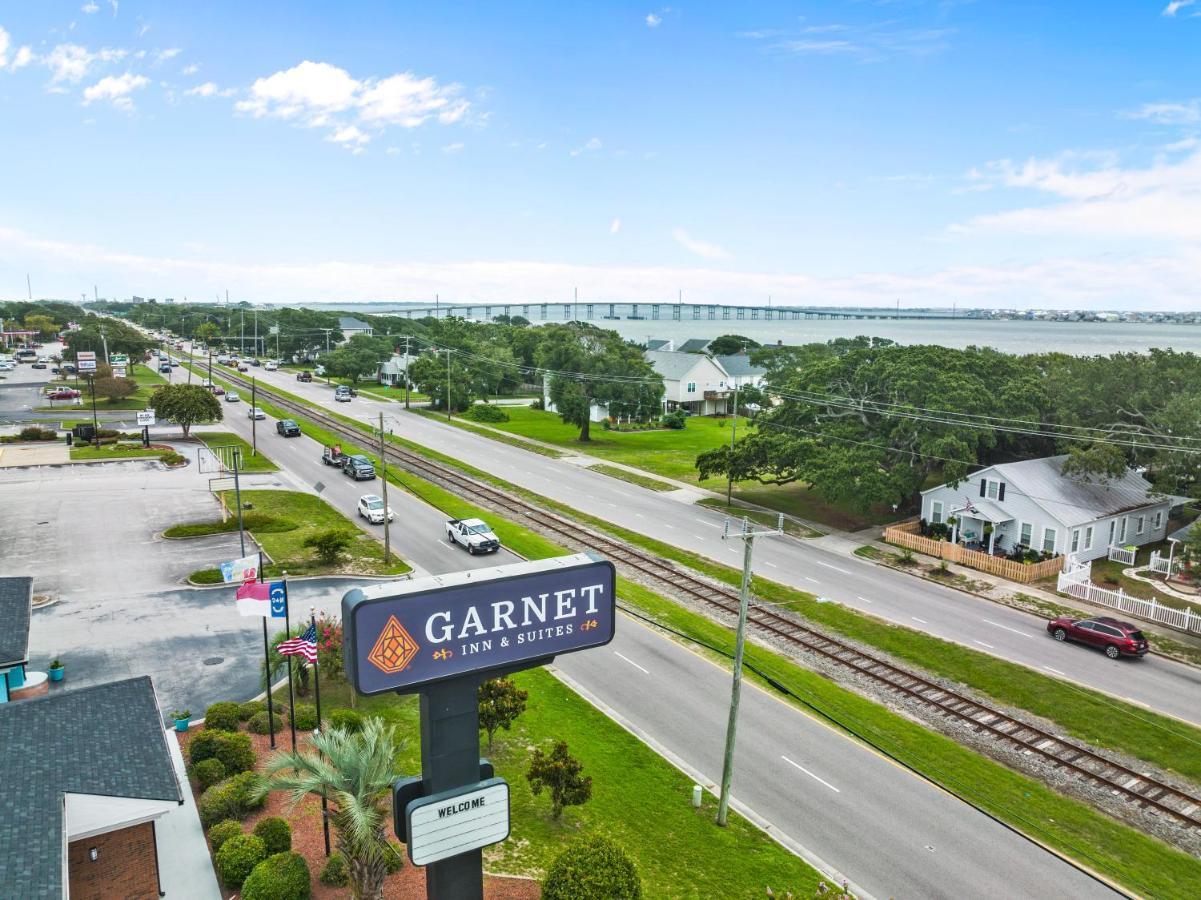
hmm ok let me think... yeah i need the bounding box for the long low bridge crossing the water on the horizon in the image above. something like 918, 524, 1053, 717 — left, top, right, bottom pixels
390, 300, 970, 322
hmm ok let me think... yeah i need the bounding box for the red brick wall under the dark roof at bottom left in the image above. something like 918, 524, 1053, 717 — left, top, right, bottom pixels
67, 822, 159, 900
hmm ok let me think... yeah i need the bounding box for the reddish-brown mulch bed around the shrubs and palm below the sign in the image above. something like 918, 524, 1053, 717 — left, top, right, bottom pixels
177, 728, 542, 900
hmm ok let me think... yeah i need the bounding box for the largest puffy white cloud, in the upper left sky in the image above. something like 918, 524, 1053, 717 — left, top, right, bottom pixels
237, 60, 470, 143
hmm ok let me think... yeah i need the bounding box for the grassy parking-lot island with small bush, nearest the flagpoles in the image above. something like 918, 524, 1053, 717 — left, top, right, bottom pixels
180, 490, 411, 583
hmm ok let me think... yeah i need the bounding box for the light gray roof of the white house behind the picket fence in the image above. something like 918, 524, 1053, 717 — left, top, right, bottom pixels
989, 455, 1167, 528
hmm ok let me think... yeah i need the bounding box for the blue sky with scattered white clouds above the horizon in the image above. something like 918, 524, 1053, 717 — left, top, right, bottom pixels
0, 0, 1201, 309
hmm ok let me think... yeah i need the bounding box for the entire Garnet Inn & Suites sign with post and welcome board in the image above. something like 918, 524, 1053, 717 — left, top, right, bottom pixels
342, 553, 617, 900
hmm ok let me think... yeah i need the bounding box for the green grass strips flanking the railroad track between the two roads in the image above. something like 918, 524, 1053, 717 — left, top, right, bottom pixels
213, 370, 1201, 896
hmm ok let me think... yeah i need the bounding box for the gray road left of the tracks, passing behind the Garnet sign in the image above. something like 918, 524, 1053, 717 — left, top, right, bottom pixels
187, 367, 1113, 898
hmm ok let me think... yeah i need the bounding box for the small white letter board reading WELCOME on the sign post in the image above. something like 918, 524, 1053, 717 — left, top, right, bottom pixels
405, 779, 509, 865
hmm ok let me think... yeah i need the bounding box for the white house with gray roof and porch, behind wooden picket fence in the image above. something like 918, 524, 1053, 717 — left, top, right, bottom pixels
921, 455, 1184, 562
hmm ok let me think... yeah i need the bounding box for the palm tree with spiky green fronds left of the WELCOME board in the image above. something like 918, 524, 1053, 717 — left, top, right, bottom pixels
261, 717, 404, 900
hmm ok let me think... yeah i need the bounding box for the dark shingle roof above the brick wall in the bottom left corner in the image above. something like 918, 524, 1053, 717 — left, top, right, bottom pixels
0, 675, 184, 900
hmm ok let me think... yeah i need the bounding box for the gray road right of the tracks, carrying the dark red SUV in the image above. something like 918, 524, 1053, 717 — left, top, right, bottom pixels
216, 355, 1201, 725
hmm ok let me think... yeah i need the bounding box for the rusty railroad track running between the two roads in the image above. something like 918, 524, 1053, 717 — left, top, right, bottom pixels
211, 371, 1201, 829
